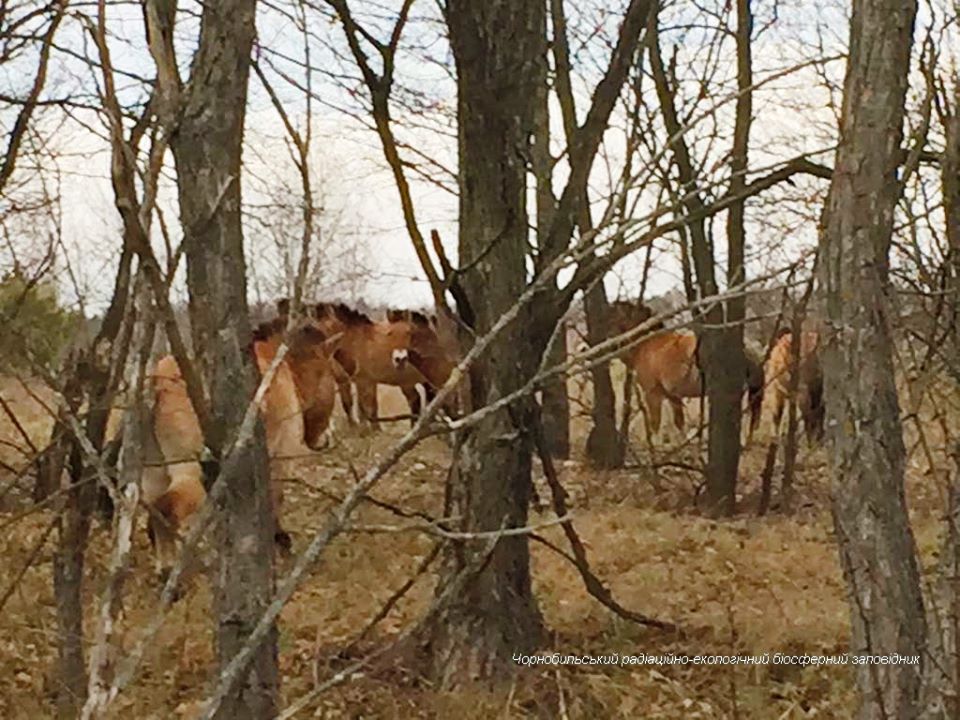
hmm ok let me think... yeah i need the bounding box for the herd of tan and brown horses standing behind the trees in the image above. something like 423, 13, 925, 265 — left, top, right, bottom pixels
142, 301, 822, 575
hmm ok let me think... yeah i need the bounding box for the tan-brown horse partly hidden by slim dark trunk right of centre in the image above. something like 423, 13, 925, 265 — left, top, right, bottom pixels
610, 301, 764, 442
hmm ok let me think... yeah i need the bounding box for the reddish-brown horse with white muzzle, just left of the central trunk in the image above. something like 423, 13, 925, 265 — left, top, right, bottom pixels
314, 303, 455, 426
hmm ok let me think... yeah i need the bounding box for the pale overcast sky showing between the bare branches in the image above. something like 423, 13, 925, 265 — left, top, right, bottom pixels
0, 0, 948, 313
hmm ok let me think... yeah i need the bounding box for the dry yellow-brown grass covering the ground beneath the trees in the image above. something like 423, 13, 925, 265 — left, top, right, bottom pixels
0, 376, 952, 720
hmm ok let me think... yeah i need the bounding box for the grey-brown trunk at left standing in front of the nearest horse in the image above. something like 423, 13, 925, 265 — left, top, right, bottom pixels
165, 0, 279, 719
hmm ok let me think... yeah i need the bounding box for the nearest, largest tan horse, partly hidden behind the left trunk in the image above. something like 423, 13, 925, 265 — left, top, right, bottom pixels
141, 321, 339, 577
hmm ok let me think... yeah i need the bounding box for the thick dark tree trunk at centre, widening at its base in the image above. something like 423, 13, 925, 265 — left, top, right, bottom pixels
427, 0, 546, 687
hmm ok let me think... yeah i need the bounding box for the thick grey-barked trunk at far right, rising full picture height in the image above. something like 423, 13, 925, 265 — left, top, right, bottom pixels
820, 0, 926, 719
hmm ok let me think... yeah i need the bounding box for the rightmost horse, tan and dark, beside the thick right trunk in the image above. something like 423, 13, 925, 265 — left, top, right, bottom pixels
762, 328, 824, 443
